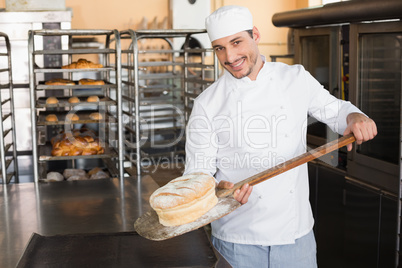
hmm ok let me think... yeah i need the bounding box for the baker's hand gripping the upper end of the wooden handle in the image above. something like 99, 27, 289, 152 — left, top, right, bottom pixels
343, 113, 377, 151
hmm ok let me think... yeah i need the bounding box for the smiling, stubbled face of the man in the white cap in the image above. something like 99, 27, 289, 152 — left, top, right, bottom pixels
212, 27, 262, 80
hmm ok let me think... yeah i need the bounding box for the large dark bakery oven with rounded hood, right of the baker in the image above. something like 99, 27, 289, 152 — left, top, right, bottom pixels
272, 0, 402, 267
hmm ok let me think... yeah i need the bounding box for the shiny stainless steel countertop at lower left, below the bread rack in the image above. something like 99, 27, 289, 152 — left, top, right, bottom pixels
0, 176, 158, 268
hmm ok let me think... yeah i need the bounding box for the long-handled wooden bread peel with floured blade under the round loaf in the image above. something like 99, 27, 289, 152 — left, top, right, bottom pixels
134, 134, 356, 241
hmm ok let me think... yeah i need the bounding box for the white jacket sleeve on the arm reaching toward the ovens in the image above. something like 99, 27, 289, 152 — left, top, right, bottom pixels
304, 67, 363, 134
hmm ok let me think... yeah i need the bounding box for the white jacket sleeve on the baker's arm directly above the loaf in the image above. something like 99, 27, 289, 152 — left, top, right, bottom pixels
184, 100, 217, 176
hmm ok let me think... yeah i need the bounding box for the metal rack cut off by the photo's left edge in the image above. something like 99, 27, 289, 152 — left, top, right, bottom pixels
0, 32, 18, 184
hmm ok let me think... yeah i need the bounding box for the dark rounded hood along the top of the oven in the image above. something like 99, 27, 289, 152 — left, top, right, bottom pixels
272, 0, 402, 27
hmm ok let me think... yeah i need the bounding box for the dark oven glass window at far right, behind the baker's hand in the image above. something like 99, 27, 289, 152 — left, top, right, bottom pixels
357, 33, 402, 164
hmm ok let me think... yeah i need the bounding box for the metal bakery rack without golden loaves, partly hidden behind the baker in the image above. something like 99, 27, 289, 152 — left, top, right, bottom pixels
120, 30, 218, 175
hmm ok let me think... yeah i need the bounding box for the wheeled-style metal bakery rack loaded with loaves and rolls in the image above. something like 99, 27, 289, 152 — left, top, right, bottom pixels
28, 30, 123, 182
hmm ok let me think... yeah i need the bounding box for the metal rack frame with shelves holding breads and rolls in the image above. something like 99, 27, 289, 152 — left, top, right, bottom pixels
28, 30, 124, 182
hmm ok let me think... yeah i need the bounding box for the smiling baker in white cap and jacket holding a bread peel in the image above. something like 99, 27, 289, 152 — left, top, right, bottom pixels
184, 6, 377, 268
